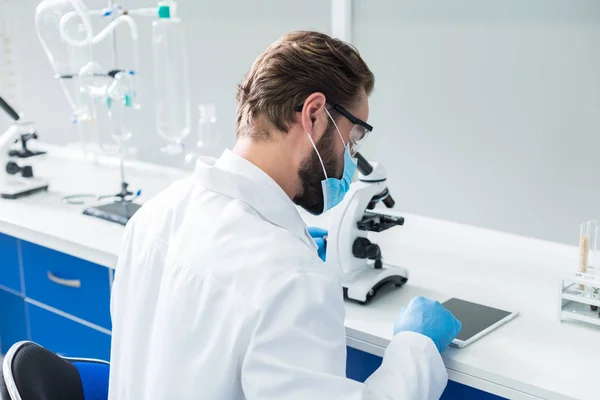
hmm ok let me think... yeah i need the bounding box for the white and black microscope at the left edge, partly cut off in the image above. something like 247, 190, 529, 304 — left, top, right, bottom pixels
0, 97, 48, 199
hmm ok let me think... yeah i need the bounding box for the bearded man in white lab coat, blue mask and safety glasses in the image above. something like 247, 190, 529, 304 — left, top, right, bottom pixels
110, 32, 460, 400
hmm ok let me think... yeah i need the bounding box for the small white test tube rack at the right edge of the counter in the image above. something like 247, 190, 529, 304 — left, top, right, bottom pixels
558, 270, 600, 326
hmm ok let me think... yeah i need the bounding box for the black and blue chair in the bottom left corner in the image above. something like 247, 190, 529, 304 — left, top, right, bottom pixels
0, 341, 110, 400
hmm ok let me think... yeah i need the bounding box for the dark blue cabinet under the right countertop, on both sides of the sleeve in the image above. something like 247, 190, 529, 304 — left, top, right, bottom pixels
346, 347, 503, 400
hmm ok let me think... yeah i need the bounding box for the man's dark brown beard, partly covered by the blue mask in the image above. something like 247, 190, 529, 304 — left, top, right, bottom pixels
293, 121, 343, 215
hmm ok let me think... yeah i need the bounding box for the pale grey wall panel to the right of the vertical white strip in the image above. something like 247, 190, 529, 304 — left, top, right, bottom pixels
354, 0, 600, 243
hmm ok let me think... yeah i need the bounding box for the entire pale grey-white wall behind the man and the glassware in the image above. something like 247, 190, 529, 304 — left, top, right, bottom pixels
4, 0, 600, 243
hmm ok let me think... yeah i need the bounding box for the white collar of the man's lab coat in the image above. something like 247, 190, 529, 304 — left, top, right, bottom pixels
195, 149, 317, 251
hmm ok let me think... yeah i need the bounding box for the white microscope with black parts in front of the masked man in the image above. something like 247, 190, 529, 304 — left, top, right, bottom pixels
326, 153, 408, 304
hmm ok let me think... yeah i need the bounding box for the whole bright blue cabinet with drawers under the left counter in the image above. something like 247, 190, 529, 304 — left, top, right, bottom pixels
0, 234, 111, 360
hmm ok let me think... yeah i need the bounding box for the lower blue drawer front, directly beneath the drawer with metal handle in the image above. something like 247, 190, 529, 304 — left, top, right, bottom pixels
27, 304, 110, 361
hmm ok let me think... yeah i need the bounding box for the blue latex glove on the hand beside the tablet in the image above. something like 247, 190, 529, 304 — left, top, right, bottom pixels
394, 297, 462, 353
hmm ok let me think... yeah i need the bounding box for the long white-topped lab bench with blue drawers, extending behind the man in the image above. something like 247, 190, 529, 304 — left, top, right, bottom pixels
0, 146, 600, 399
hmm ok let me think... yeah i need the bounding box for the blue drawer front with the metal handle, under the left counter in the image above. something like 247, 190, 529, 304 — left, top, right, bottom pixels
21, 242, 111, 330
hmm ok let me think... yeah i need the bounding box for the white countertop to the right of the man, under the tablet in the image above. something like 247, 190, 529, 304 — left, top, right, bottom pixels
304, 209, 600, 399
